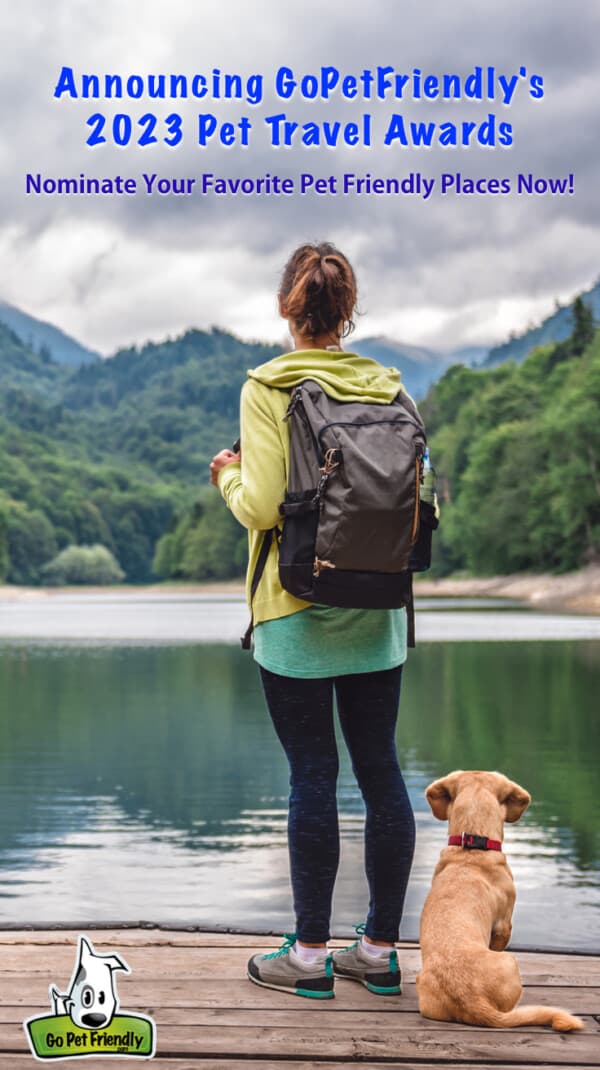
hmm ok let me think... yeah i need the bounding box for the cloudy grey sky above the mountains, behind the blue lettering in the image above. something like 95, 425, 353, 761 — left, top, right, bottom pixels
0, 0, 600, 354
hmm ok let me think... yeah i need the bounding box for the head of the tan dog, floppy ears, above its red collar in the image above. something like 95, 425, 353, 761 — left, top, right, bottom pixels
425, 769, 532, 840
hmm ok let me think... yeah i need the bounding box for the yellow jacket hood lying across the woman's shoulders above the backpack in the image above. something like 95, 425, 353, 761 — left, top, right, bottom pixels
247, 349, 404, 403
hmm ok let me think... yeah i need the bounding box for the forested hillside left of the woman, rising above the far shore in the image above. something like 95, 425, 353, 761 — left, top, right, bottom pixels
0, 324, 278, 584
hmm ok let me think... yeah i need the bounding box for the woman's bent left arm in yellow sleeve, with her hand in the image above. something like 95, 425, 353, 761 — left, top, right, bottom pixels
211, 379, 288, 531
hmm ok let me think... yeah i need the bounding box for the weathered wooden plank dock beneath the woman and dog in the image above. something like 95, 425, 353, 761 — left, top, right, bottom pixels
0, 928, 600, 1070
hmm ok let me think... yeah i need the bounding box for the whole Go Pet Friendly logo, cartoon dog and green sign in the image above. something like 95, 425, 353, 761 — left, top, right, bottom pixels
24, 933, 156, 1061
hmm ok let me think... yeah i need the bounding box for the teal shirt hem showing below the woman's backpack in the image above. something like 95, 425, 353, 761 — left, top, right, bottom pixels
252, 602, 406, 677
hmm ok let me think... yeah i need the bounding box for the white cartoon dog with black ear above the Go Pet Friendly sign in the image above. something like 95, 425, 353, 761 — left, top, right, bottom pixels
49, 935, 130, 1029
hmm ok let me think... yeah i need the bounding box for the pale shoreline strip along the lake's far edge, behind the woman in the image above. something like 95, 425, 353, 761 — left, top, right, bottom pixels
0, 565, 600, 615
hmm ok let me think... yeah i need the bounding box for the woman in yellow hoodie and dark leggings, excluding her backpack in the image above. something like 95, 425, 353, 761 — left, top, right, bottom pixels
210, 243, 415, 998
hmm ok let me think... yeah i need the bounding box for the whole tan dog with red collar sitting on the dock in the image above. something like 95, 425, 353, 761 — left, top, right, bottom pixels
417, 769, 584, 1031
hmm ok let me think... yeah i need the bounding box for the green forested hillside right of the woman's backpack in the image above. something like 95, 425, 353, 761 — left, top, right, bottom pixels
421, 300, 600, 575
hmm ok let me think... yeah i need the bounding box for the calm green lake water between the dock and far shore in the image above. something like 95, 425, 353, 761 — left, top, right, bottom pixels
0, 593, 600, 950
